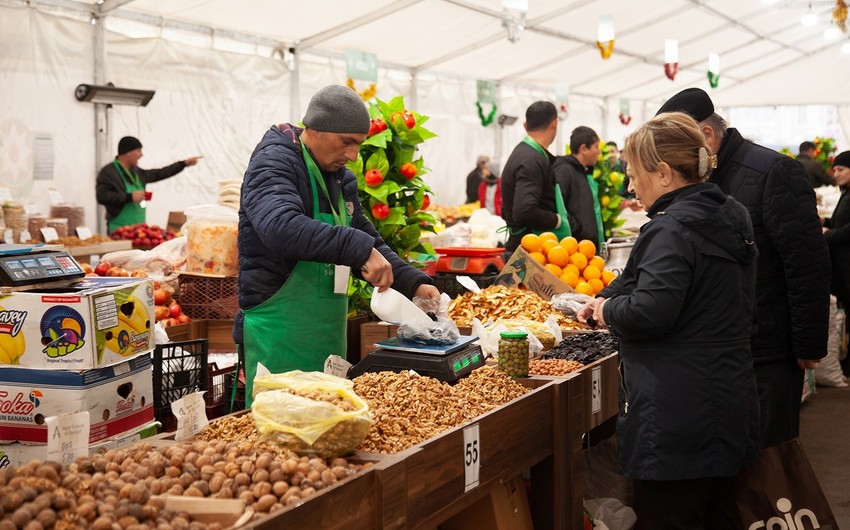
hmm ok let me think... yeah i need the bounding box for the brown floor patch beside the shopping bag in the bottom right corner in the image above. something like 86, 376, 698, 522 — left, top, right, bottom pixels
800, 387, 850, 530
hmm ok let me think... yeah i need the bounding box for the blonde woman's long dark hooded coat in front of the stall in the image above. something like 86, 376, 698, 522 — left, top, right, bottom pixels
599, 183, 759, 480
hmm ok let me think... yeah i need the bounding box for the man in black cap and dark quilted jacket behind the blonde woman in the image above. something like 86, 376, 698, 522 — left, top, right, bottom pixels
657, 88, 830, 447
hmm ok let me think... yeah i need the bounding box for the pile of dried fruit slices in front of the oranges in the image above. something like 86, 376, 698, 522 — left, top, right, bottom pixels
449, 285, 584, 329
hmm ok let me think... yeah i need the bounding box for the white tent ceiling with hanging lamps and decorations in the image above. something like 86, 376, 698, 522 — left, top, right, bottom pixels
73, 0, 850, 107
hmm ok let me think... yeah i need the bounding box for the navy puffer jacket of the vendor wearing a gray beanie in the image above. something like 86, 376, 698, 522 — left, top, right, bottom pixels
233, 124, 433, 343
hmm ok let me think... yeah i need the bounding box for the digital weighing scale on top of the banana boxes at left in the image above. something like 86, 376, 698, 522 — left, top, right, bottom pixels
0, 245, 86, 290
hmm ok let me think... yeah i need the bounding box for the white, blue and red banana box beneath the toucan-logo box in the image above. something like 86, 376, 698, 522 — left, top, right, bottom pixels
0, 355, 154, 444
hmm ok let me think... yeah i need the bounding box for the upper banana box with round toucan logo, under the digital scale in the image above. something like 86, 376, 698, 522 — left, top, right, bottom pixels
0, 277, 155, 370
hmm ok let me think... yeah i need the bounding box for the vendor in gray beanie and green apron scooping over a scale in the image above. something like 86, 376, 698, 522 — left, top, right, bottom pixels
233, 85, 440, 398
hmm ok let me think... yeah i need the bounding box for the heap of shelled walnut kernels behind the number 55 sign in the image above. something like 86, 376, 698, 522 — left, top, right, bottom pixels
354, 367, 529, 453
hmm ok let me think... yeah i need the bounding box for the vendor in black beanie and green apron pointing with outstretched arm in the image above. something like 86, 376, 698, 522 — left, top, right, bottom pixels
95, 136, 198, 233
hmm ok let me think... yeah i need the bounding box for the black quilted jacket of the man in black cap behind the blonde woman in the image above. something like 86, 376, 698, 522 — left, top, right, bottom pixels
710, 128, 830, 365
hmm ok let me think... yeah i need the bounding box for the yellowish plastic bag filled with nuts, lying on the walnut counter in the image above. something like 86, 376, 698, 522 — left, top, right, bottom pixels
251, 370, 372, 458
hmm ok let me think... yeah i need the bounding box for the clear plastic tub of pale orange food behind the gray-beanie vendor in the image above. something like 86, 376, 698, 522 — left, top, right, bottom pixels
182, 204, 239, 276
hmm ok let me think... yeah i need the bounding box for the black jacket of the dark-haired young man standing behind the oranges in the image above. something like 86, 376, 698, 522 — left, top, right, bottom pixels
552, 155, 601, 248
